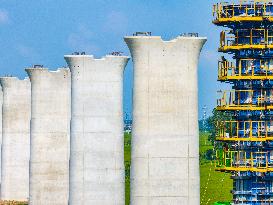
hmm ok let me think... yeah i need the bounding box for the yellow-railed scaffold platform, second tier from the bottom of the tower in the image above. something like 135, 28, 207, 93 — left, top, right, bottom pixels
216, 121, 273, 142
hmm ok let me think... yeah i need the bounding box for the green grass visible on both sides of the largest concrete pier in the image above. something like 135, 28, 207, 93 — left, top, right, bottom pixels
124, 132, 232, 205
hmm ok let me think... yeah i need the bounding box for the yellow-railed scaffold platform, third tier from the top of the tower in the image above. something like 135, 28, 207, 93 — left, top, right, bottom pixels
218, 59, 273, 80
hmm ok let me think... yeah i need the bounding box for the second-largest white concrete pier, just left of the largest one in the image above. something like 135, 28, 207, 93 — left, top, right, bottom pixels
65, 55, 128, 205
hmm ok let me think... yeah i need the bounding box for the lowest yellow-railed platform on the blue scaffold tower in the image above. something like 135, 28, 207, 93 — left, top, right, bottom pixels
215, 150, 273, 172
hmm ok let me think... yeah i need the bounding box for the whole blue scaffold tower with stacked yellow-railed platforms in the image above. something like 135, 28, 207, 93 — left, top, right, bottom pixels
213, 0, 273, 205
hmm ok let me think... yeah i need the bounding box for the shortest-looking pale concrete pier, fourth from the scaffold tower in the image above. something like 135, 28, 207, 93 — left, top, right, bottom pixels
0, 77, 31, 201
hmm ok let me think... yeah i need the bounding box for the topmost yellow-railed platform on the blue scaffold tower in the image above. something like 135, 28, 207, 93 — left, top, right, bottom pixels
213, 0, 273, 23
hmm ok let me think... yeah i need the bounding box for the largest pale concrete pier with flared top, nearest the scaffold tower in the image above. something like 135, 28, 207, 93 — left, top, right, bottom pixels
125, 36, 206, 205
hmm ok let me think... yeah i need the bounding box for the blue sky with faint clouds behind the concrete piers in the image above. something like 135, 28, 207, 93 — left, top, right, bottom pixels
0, 0, 225, 116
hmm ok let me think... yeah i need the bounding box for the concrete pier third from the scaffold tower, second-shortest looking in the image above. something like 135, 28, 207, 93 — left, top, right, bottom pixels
26, 68, 71, 205
